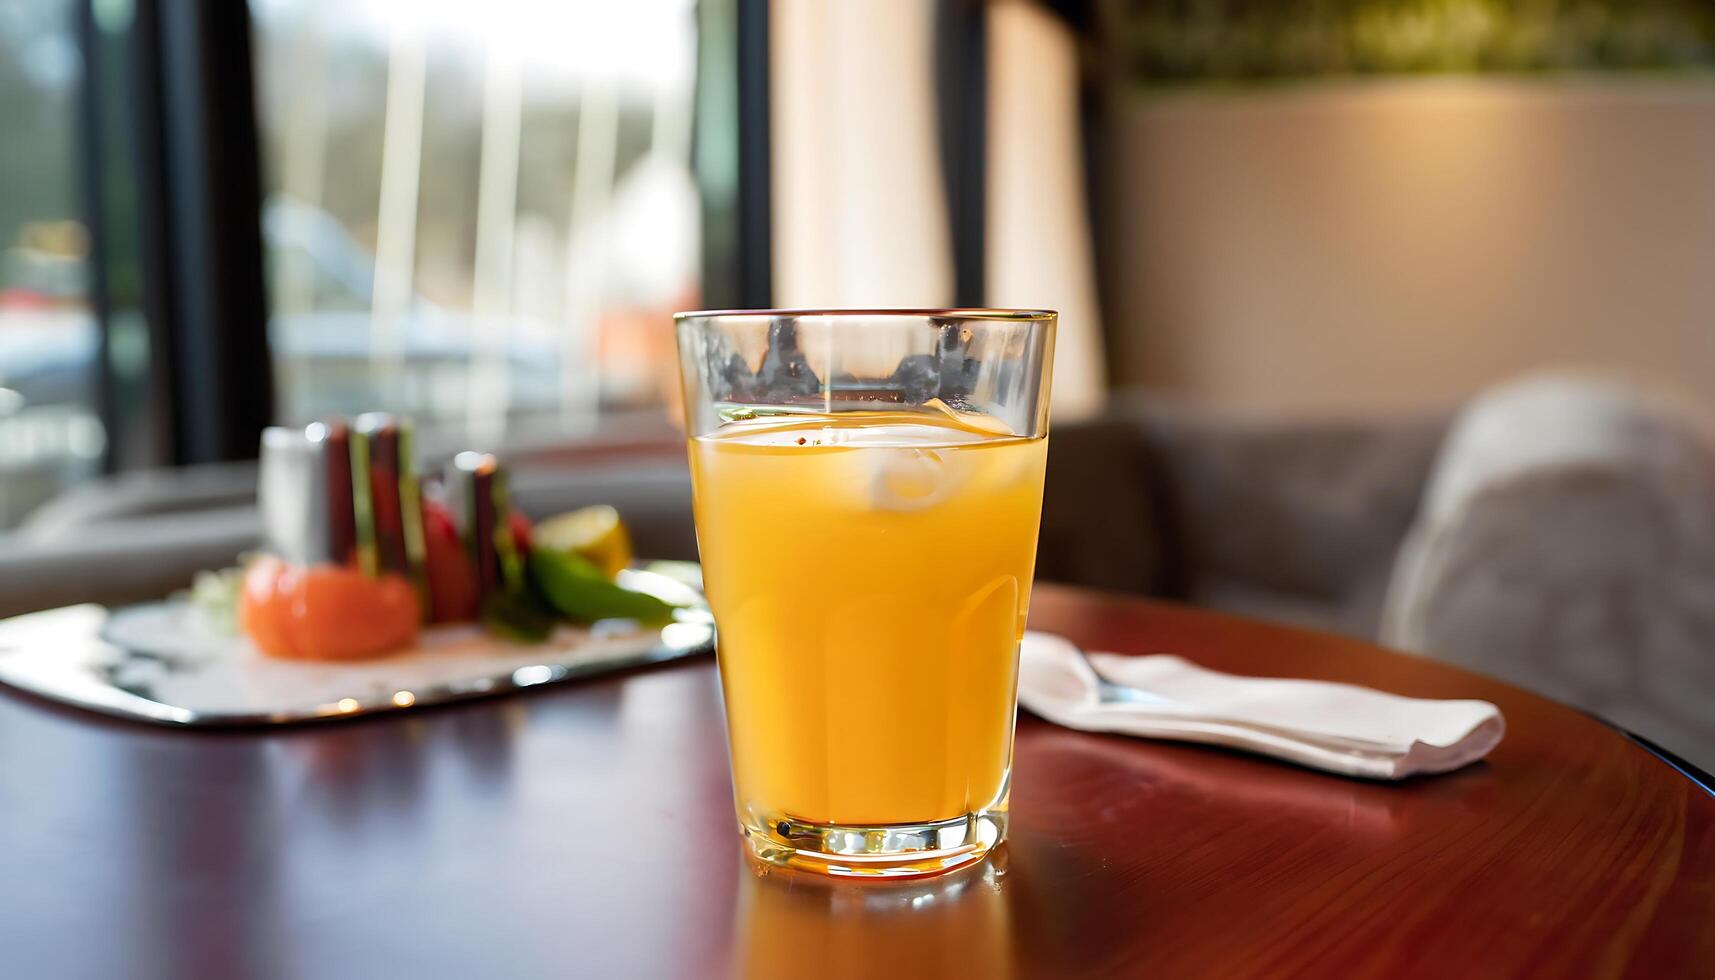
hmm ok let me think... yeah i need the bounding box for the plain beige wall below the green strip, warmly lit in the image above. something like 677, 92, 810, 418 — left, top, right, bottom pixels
1103, 79, 1715, 417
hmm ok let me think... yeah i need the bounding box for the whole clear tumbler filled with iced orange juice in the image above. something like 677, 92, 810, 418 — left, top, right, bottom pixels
677, 309, 1055, 877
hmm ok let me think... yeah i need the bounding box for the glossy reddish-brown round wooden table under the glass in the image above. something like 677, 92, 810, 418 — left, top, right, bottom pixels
0, 587, 1715, 980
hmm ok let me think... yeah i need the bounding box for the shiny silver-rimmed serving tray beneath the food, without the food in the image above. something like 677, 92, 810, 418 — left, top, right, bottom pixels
0, 565, 715, 726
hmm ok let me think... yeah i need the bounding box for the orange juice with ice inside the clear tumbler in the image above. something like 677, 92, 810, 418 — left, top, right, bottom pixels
691, 410, 1048, 834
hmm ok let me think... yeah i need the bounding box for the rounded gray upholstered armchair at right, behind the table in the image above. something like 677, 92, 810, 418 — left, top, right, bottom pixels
1381, 378, 1715, 769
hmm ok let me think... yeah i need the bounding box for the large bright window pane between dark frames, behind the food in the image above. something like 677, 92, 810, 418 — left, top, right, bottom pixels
250, 0, 700, 438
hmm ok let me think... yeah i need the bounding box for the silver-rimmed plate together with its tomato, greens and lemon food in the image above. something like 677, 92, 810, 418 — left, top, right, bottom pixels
0, 415, 715, 726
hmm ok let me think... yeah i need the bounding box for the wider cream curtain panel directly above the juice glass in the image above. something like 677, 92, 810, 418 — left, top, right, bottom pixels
768, 0, 954, 307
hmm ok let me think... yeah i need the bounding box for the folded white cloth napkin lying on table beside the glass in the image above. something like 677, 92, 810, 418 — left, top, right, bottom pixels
1019, 632, 1506, 779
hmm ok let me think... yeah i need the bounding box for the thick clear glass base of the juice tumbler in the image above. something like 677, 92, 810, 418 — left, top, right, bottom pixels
739, 810, 1007, 879
